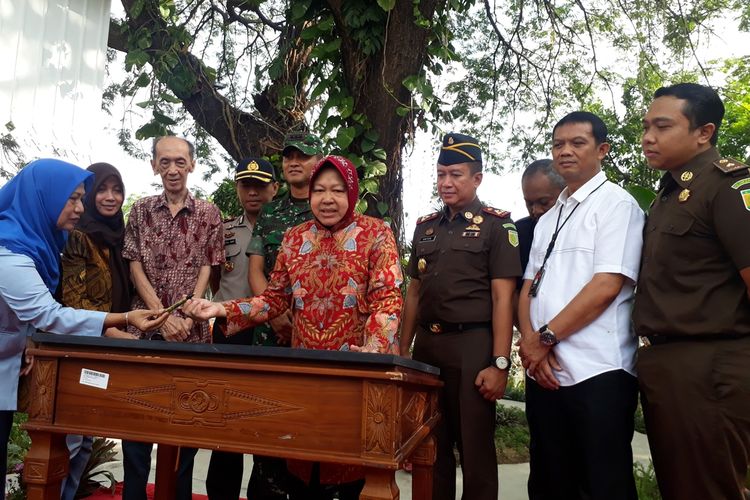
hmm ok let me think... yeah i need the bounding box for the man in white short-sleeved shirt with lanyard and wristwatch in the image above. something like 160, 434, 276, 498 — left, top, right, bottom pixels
518, 112, 644, 500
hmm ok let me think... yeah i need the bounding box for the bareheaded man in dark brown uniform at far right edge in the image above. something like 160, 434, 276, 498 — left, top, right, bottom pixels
633, 83, 750, 500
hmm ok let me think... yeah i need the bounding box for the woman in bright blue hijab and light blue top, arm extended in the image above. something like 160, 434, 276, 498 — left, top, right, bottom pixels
0, 160, 169, 498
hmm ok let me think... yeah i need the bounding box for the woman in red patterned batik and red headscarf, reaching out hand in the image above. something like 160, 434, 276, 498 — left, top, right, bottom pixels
183, 156, 402, 500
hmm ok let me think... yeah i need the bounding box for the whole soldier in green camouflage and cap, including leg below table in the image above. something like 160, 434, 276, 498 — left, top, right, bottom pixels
242, 133, 323, 500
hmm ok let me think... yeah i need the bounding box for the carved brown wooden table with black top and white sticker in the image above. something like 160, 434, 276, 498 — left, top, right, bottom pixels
24, 334, 442, 500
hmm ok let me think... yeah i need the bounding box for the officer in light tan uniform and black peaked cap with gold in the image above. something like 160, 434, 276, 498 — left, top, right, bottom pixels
206, 158, 279, 500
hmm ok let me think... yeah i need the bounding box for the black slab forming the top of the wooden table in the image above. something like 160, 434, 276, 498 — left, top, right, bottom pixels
32, 332, 440, 375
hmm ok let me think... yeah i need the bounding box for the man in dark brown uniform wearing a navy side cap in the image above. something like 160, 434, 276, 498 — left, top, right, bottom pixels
400, 134, 521, 500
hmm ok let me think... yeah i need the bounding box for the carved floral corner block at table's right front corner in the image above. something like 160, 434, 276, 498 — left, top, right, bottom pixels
362, 382, 398, 456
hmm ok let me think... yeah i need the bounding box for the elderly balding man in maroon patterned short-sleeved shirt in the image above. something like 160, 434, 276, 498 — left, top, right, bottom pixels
122, 136, 224, 500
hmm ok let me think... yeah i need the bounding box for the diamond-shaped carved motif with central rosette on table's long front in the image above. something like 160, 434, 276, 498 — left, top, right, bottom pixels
112, 377, 301, 427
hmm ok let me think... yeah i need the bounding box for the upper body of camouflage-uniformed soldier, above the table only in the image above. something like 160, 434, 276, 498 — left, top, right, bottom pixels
247, 133, 323, 345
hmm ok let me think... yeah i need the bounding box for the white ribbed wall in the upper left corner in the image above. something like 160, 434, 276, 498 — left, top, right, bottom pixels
0, 0, 110, 168
